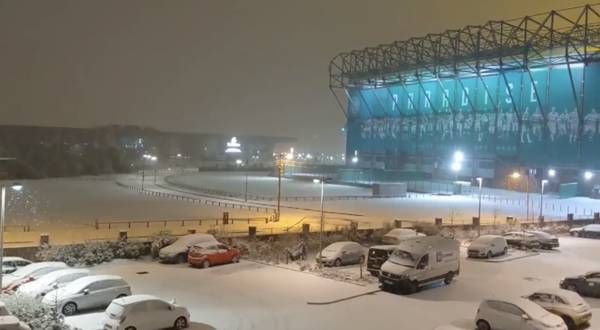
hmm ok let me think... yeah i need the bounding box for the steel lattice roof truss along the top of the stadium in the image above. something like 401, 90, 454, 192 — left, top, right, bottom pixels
329, 3, 600, 115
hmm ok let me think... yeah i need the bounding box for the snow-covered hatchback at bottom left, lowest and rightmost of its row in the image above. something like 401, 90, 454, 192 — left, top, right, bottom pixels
103, 295, 190, 330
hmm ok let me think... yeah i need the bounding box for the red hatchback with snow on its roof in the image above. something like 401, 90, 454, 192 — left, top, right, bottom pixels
188, 242, 240, 268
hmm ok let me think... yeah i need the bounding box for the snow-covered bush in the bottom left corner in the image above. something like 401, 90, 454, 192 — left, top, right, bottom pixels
0, 294, 72, 330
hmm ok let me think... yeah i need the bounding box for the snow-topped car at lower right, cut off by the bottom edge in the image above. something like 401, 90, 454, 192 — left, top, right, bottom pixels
475, 298, 567, 330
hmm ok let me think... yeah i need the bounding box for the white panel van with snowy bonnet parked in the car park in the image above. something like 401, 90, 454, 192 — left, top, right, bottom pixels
379, 237, 460, 293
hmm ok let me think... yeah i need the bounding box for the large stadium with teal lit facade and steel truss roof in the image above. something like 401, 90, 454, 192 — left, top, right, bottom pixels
329, 4, 600, 192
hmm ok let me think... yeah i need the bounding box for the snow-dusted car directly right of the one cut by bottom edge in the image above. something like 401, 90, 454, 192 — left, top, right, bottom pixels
523, 289, 592, 330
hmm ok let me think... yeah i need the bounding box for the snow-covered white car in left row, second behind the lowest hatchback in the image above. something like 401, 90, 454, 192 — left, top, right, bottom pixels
17, 268, 90, 299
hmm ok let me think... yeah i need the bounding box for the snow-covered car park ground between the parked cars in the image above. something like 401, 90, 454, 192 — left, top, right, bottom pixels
67, 237, 600, 330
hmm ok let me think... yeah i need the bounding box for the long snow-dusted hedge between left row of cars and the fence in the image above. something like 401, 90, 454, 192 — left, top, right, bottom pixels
36, 240, 146, 266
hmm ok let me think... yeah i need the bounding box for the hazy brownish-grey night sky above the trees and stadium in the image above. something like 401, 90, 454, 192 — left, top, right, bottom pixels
0, 0, 586, 152
